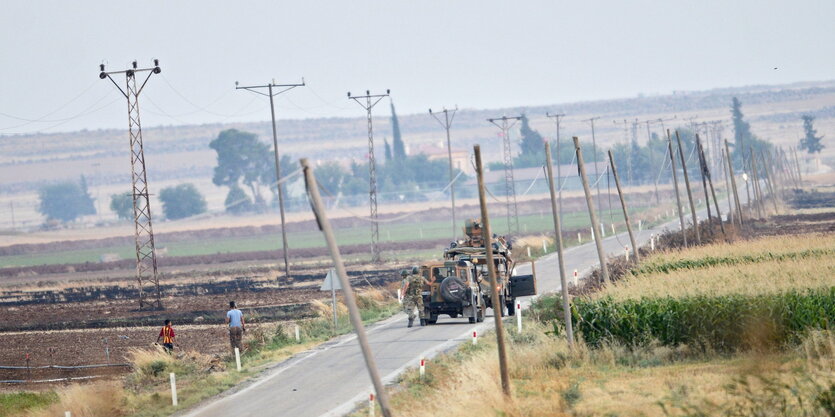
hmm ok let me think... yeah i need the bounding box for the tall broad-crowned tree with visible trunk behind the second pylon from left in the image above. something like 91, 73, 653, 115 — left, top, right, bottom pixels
209, 129, 272, 207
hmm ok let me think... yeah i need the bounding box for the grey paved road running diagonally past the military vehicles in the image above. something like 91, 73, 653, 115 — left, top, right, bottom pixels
181, 203, 720, 417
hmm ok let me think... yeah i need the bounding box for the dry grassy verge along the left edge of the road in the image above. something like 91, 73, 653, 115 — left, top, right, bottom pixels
0, 290, 400, 417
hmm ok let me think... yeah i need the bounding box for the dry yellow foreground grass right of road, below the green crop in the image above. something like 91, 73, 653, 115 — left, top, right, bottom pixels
380, 325, 835, 417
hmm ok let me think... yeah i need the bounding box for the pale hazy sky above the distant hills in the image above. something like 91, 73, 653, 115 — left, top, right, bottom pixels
0, 0, 835, 134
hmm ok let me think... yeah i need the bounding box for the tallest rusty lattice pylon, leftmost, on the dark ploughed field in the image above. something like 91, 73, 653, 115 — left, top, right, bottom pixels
99, 59, 162, 310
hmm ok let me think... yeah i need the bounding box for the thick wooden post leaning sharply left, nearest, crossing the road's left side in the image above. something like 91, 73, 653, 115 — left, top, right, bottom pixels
301, 158, 391, 417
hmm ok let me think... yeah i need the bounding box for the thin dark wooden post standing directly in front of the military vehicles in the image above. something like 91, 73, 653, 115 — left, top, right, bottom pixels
473, 145, 510, 397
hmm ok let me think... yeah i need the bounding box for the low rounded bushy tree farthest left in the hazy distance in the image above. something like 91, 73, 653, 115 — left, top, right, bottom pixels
38, 177, 96, 222
